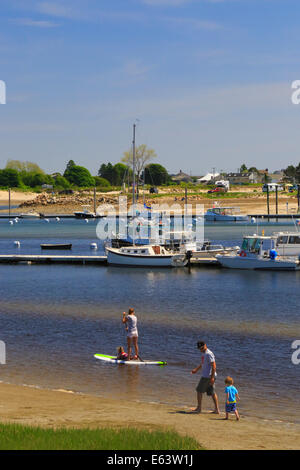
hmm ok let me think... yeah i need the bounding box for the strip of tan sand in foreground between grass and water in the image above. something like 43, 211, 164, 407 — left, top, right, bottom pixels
0, 383, 300, 450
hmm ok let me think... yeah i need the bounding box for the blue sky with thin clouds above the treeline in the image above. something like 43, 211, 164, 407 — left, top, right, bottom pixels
0, 0, 300, 175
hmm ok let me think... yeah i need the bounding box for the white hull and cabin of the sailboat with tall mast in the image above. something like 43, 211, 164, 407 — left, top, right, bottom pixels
106, 245, 188, 267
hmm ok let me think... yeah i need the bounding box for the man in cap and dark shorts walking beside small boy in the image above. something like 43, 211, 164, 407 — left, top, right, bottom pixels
192, 341, 220, 414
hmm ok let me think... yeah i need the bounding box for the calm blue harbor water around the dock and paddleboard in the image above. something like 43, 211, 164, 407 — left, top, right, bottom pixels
0, 220, 300, 422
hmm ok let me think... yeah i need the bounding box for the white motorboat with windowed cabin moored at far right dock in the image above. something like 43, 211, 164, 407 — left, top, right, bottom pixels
216, 234, 300, 271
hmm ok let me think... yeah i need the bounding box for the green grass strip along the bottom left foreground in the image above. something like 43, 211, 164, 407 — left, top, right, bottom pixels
0, 424, 201, 450
